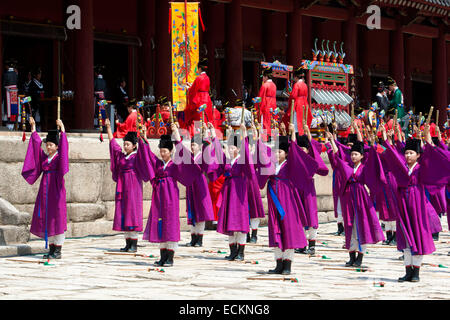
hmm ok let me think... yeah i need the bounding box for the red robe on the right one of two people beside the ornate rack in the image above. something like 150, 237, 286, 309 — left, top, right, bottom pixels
283, 80, 312, 135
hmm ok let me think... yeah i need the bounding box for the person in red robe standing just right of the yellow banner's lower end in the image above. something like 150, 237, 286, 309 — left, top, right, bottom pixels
185, 58, 213, 137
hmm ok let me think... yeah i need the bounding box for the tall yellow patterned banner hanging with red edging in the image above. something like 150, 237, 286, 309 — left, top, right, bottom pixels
170, 2, 199, 111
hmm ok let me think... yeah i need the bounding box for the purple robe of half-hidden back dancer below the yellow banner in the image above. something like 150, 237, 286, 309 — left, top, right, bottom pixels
186, 153, 214, 225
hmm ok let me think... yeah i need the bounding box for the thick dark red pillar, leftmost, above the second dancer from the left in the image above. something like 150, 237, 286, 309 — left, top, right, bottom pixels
73, 0, 94, 130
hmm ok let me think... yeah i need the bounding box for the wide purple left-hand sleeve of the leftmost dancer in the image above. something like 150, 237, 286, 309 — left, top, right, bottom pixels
22, 132, 46, 184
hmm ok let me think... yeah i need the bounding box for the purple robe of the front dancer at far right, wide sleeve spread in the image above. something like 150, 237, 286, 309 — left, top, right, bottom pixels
384, 142, 450, 255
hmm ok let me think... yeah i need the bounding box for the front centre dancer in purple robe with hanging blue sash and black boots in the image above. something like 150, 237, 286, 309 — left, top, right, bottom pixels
256, 124, 312, 274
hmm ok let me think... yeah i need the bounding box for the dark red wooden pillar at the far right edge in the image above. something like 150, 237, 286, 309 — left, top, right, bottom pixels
432, 23, 448, 125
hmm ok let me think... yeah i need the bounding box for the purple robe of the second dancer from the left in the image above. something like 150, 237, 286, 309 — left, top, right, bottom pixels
109, 139, 150, 232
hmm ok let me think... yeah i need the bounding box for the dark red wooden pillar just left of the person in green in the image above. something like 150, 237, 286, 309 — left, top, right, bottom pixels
389, 21, 405, 92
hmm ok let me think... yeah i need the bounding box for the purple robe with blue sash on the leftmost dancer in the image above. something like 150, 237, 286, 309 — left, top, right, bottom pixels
22, 132, 69, 245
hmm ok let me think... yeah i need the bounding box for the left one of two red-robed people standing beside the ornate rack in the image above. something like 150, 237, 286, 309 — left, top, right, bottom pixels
257, 67, 277, 140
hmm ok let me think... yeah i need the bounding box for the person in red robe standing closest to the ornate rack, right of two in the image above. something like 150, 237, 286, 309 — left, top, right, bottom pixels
283, 68, 312, 135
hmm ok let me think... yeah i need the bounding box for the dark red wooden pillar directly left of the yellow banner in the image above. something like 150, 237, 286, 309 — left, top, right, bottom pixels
155, 0, 172, 101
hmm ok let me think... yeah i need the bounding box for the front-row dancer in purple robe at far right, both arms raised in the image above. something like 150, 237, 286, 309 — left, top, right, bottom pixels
381, 124, 450, 282
